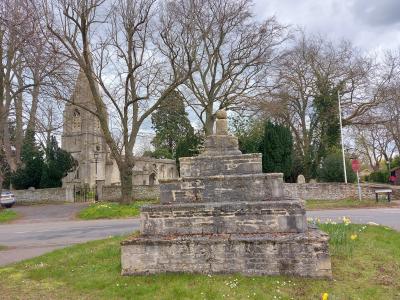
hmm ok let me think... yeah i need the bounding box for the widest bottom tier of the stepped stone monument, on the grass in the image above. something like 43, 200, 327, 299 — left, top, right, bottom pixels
121, 229, 332, 278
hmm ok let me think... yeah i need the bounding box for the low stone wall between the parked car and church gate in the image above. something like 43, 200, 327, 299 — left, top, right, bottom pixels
12, 188, 74, 204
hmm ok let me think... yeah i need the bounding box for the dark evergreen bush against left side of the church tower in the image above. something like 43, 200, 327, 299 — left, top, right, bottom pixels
40, 136, 76, 188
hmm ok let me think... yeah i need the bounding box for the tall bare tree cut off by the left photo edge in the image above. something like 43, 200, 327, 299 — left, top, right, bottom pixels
0, 0, 40, 186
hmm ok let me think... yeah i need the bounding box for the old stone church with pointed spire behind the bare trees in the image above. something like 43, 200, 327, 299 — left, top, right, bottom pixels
61, 72, 178, 187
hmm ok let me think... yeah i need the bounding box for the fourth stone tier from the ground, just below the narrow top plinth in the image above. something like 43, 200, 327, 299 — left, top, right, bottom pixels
179, 153, 262, 178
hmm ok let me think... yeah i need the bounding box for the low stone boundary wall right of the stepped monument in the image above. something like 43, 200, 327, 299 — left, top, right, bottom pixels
284, 182, 400, 200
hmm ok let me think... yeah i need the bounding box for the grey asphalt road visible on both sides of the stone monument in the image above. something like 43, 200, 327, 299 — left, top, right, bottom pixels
0, 204, 400, 265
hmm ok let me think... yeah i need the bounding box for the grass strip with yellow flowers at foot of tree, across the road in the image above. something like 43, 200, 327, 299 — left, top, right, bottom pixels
78, 200, 158, 220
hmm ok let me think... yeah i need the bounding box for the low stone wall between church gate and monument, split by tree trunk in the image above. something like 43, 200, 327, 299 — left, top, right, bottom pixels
99, 185, 160, 201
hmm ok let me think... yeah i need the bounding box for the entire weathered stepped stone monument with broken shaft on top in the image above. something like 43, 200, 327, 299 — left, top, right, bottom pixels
121, 110, 332, 278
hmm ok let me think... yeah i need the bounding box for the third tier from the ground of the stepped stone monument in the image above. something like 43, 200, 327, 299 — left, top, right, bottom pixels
160, 173, 283, 203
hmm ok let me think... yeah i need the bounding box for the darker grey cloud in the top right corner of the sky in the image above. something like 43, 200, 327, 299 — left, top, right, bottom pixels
352, 0, 400, 26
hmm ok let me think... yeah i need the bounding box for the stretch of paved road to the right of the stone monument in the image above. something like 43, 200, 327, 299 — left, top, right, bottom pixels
307, 208, 400, 231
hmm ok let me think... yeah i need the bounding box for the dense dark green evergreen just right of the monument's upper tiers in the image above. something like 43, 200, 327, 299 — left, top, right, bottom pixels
262, 121, 293, 179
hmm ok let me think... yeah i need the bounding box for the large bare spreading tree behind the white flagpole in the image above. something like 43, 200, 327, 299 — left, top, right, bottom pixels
257, 32, 381, 177
